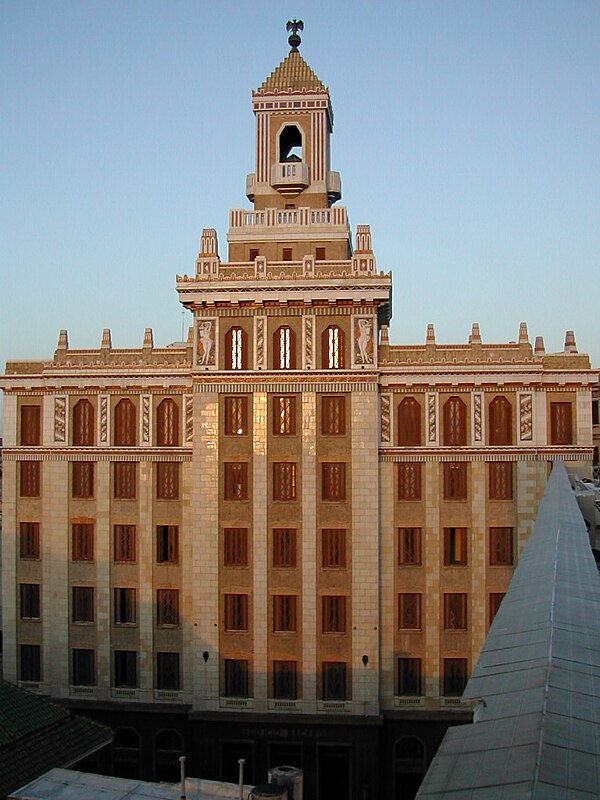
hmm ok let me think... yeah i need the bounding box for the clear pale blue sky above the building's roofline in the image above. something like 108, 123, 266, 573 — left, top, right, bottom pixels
0, 0, 600, 400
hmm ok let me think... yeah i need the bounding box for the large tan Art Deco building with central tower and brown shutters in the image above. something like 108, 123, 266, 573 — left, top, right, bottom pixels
1, 26, 597, 800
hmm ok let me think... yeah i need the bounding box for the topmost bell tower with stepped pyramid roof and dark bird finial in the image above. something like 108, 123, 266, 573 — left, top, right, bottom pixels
246, 20, 342, 211
